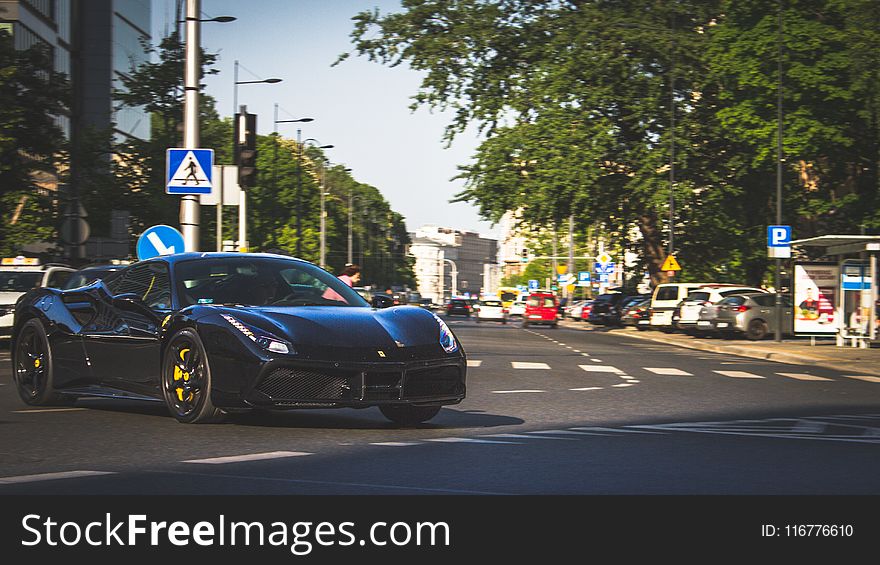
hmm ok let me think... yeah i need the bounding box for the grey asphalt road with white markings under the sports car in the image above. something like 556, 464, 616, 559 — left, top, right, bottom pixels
0, 318, 880, 495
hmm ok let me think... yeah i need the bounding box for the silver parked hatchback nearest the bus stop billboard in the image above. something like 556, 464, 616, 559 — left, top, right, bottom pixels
712, 292, 794, 341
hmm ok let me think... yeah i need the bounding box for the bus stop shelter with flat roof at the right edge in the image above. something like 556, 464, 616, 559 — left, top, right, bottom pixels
791, 235, 880, 347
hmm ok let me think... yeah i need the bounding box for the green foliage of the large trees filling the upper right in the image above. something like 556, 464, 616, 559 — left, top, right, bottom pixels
352, 0, 880, 284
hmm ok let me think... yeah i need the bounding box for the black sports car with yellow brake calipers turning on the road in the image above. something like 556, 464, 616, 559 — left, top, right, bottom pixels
10, 253, 467, 424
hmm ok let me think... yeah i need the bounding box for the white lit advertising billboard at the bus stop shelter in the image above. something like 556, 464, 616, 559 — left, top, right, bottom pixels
794, 263, 840, 335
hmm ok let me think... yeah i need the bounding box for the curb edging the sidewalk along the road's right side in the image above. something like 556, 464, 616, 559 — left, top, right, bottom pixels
563, 322, 880, 376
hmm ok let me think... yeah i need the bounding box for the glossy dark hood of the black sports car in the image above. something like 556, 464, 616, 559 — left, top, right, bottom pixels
222, 306, 440, 349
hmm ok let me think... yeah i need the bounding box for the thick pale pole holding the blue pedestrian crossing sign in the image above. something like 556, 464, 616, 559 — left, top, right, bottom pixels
180, 0, 201, 251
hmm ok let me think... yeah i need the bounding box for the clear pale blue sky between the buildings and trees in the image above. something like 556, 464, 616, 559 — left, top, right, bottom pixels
153, 0, 497, 237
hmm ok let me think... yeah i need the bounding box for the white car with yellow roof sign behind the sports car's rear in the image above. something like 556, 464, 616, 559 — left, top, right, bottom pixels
0, 256, 75, 336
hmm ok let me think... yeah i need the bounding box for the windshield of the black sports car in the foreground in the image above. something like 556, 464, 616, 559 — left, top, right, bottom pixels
175, 257, 369, 307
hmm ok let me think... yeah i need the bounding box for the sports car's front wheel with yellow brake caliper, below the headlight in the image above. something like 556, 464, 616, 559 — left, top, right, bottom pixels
162, 328, 223, 424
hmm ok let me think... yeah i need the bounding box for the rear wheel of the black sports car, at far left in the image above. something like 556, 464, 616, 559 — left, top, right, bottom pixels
12, 318, 76, 406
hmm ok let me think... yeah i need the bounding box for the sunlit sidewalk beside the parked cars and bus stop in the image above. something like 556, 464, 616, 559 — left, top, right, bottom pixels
563, 321, 880, 377
